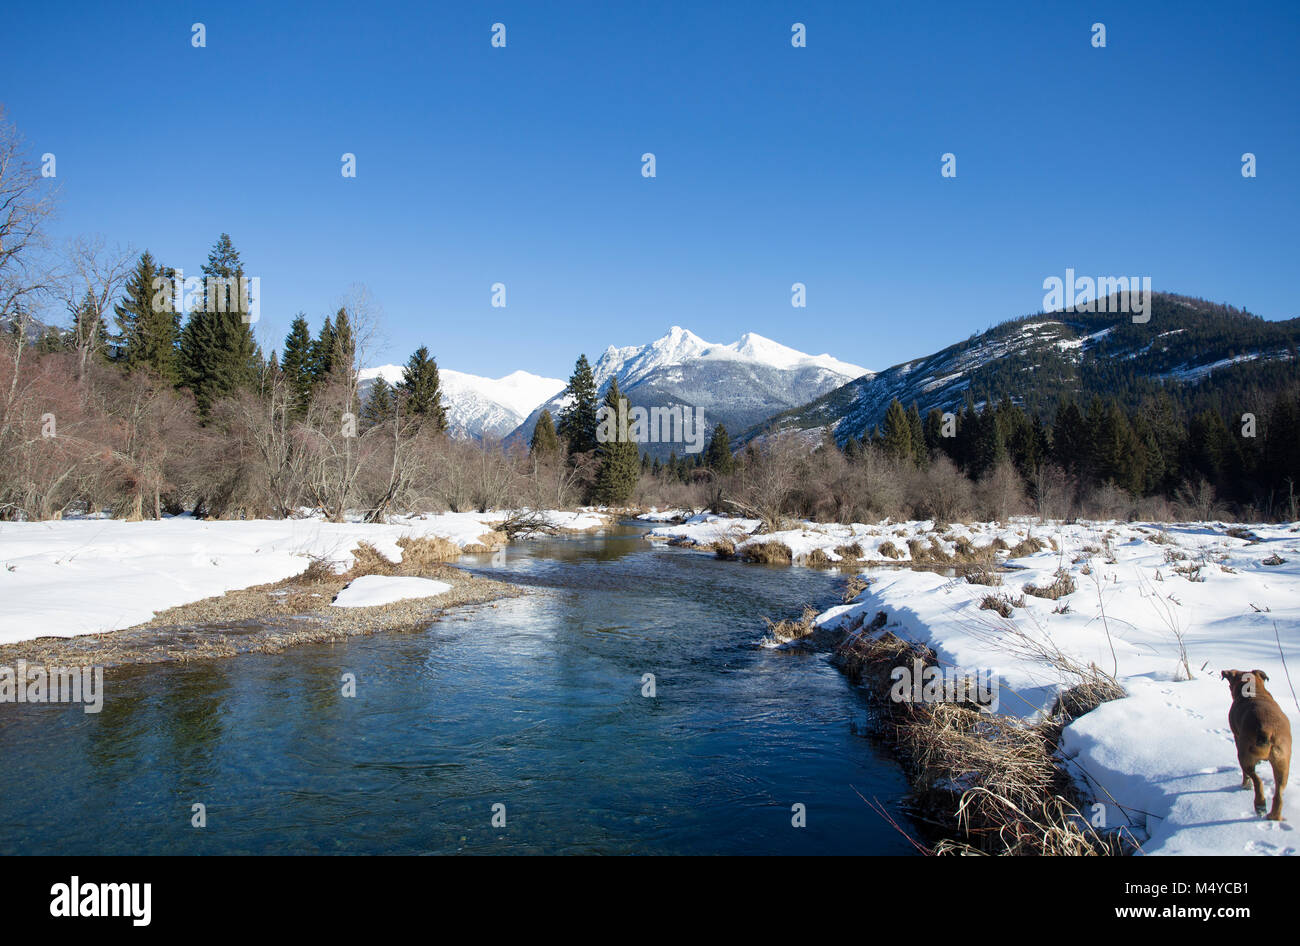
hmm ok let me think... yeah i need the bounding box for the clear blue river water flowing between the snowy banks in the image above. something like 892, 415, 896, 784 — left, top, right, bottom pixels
0, 525, 911, 855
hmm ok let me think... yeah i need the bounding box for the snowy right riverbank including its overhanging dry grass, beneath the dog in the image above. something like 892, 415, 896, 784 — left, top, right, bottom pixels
681, 516, 1300, 855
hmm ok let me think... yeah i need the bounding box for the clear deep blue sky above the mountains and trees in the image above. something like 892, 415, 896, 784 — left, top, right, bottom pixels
0, 0, 1300, 377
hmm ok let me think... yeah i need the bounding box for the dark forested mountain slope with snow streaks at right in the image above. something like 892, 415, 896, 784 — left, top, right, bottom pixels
735, 292, 1300, 444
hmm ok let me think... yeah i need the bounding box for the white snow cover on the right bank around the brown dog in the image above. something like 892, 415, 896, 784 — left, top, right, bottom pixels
800, 521, 1300, 854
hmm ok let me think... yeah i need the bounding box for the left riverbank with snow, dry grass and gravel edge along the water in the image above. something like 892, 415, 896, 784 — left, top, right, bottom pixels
0, 512, 608, 654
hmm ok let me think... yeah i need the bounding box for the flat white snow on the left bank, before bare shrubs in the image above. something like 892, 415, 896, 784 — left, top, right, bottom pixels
0, 512, 607, 645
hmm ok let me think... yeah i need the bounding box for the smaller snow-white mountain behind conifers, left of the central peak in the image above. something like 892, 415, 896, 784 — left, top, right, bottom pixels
359, 365, 566, 439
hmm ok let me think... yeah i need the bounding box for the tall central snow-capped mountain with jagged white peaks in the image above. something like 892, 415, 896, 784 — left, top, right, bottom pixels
510, 325, 870, 456
